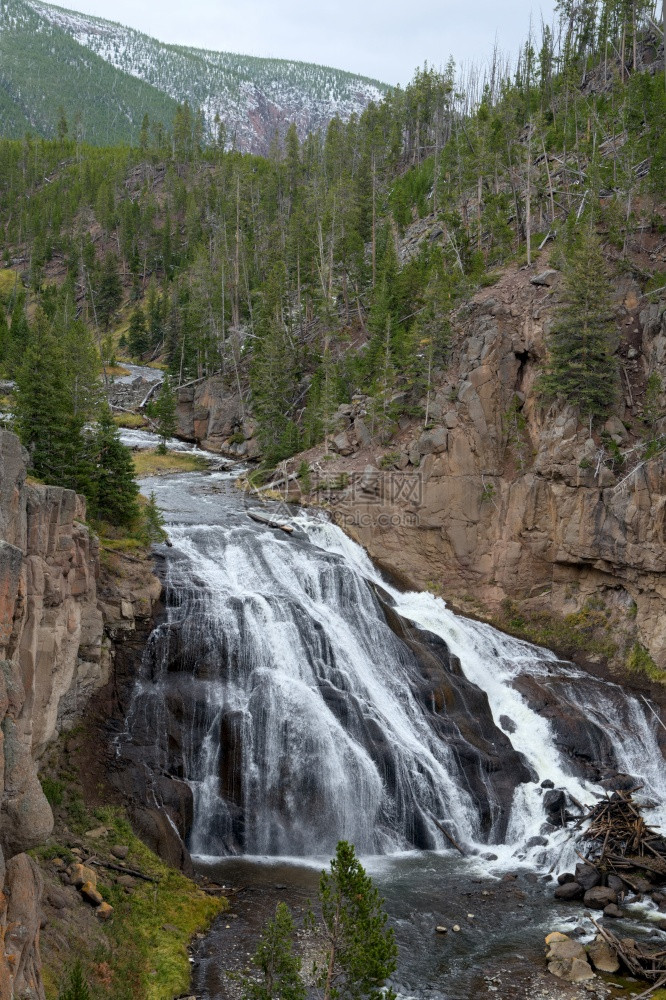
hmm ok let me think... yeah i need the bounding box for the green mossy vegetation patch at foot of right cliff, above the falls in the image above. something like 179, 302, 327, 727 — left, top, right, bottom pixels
492, 600, 617, 659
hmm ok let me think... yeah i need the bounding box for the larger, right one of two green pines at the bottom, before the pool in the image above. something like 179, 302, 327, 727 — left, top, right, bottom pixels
317, 840, 398, 1000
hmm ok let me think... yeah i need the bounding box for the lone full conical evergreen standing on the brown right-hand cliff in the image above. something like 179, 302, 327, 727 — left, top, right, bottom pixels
540, 223, 618, 417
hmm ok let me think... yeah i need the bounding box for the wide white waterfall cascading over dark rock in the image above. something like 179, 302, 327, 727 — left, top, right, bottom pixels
123, 488, 666, 860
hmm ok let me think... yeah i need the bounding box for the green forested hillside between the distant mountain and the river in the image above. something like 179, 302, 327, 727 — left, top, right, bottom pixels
0, 0, 666, 480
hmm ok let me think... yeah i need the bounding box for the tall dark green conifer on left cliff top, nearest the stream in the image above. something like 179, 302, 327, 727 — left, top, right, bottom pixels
92, 408, 139, 528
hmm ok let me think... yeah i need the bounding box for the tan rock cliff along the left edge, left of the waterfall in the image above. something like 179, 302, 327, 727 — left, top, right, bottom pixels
0, 430, 160, 998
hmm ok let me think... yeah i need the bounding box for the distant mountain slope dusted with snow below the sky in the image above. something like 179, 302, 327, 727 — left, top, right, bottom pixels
0, 0, 386, 152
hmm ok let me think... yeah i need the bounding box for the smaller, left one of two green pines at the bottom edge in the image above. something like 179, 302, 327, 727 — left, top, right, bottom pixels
242, 903, 307, 1000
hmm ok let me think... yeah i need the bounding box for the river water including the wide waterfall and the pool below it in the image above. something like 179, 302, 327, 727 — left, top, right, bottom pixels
118, 432, 666, 1000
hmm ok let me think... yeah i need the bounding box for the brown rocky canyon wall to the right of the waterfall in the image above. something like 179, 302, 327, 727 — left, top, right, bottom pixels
324, 271, 666, 667
